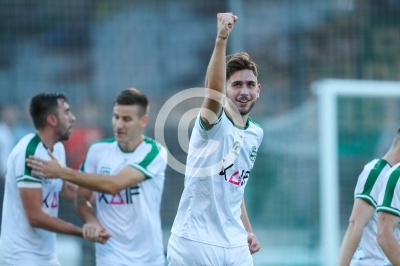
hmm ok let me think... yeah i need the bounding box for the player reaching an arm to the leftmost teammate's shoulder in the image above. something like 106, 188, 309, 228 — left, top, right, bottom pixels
28, 89, 167, 266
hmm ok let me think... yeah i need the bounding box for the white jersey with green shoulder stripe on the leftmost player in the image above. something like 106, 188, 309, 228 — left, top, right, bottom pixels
0, 134, 65, 265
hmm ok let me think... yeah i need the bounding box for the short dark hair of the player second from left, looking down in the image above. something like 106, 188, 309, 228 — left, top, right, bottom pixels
114, 88, 149, 117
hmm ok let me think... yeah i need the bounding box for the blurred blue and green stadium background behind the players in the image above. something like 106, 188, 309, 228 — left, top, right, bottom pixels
0, 0, 400, 266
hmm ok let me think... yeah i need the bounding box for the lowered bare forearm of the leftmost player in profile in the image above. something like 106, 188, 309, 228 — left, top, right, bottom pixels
30, 212, 82, 237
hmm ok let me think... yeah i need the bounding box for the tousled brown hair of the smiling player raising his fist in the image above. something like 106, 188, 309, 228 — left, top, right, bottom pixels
226, 52, 258, 80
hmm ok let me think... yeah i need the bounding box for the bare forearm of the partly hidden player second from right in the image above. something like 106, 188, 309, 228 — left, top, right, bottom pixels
339, 223, 364, 266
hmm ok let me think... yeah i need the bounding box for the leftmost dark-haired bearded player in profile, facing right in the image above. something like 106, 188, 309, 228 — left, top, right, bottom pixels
0, 93, 106, 266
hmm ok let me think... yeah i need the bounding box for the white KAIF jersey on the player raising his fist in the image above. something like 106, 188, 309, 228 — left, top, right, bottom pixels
171, 111, 264, 247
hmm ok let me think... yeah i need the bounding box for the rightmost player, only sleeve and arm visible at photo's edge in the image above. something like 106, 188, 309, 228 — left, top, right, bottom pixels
377, 129, 400, 265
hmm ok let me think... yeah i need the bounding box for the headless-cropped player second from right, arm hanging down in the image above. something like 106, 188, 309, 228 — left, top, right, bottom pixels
339, 129, 400, 266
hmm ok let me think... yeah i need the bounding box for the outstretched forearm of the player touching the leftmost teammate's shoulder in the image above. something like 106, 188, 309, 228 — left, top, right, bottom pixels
60, 167, 119, 194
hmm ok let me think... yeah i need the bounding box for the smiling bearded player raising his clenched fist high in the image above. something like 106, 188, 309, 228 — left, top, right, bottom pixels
167, 13, 263, 266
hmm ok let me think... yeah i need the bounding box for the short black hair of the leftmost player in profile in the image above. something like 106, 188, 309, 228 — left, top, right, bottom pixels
29, 93, 68, 129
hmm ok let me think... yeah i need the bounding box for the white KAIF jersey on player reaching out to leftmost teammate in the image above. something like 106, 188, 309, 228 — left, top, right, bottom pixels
81, 137, 167, 266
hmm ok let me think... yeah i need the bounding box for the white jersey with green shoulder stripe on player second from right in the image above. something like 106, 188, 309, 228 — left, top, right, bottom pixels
350, 159, 391, 266
